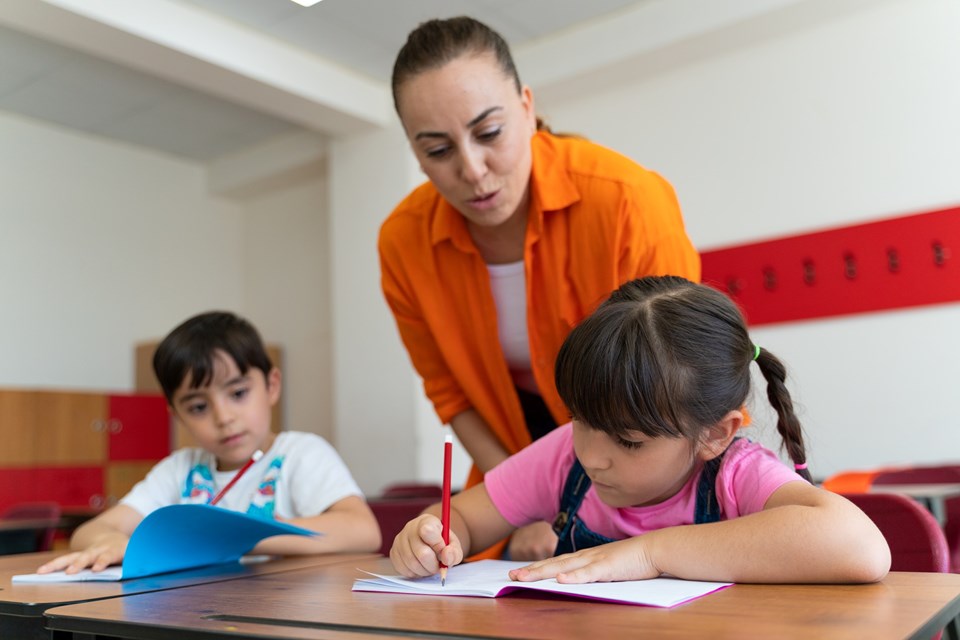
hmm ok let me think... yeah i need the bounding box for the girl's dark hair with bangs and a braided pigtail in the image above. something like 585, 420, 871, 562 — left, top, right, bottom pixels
556, 276, 810, 480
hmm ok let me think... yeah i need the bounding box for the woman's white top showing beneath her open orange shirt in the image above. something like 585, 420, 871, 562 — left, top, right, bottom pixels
487, 260, 540, 394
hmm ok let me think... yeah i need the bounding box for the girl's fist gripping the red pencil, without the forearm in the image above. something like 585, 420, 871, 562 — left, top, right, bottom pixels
390, 514, 463, 578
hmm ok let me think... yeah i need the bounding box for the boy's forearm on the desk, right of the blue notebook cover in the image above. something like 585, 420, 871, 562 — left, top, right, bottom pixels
251, 496, 380, 555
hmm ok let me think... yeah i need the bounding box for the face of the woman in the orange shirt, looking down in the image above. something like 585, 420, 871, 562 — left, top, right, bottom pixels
397, 54, 536, 227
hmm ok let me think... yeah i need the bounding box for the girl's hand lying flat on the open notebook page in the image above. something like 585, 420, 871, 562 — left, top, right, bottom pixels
510, 536, 660, 584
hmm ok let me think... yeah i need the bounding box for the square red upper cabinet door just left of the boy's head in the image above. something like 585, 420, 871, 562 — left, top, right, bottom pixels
106, 394, 171, 461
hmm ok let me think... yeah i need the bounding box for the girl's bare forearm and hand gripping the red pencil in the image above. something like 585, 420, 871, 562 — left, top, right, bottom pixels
390, 483, 516, 578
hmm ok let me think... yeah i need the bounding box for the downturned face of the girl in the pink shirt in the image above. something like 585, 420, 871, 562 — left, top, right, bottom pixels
573, 420, 696, 508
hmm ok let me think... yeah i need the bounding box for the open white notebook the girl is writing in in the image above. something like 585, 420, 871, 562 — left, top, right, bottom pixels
353, 560, 733, 607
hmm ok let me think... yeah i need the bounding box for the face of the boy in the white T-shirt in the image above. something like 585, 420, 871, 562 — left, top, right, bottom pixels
172, 351, 280, 471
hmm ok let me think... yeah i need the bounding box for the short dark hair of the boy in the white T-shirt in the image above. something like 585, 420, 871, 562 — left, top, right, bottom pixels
153, 311, 273, 404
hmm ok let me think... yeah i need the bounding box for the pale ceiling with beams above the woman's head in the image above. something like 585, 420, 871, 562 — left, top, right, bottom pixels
0, 0, 856, 169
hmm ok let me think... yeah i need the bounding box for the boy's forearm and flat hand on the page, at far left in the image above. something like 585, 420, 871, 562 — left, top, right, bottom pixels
37, 504, 143, 574
